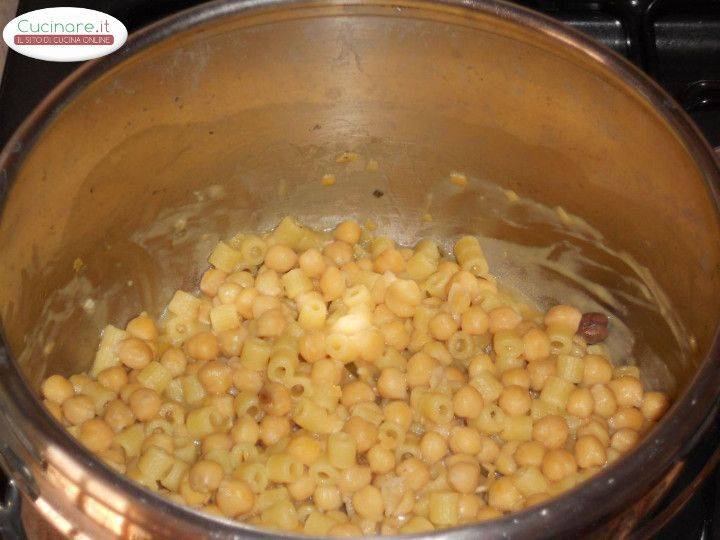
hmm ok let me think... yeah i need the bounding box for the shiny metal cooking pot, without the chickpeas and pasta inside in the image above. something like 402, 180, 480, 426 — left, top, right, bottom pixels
0, 0, 720, 539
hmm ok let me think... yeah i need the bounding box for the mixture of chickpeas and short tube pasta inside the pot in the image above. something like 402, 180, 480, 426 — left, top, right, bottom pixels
42, 218, 669, 536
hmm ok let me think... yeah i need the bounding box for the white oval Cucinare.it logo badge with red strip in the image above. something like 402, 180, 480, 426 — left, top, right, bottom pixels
3, 7, 127, 62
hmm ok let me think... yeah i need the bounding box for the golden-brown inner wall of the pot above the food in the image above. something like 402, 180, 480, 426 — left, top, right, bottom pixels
0, 3, 720, 396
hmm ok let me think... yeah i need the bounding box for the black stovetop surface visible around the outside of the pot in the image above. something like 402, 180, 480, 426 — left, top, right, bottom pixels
0, 0, 720, 540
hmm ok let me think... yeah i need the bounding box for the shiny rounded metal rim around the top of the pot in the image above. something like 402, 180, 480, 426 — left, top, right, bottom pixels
0, 0, 720, 538
